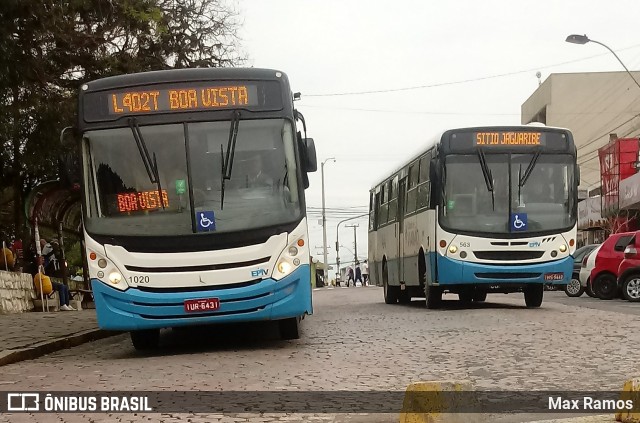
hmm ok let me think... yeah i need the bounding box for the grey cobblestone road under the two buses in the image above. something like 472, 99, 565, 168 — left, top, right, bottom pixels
0, 287, 640, 422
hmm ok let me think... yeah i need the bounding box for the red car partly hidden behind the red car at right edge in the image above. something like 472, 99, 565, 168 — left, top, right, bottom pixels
589, 232, 636, 300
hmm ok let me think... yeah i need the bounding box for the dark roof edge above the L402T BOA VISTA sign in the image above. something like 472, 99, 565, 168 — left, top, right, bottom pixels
82, 68, 288, 91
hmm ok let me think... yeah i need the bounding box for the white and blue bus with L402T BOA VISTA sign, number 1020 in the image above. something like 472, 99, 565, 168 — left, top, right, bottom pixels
78, 69, 317, 349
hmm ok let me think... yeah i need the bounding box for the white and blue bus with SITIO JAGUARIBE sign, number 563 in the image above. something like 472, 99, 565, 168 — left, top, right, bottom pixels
369, 124, 580, 308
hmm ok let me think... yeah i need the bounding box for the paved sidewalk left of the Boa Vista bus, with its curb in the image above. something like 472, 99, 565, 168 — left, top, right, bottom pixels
0, 309, 118, 366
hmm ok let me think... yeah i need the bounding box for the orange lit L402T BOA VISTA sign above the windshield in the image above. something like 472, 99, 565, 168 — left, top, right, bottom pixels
107, 85, 259, 115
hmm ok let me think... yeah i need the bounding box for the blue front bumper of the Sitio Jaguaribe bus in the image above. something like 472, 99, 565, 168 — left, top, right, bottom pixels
438, 255, 573, 285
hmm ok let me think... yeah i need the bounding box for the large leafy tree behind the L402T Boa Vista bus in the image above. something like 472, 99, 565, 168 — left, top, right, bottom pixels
0, 0, 245, 240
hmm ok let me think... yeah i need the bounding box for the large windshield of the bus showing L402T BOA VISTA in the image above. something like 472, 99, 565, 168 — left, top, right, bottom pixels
83, 119, 301, 236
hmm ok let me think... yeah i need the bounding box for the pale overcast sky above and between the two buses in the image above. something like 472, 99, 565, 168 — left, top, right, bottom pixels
230, 0, 640, 275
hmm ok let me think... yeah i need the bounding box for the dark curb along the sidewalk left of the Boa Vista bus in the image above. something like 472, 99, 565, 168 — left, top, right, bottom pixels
0, 329, 124, 366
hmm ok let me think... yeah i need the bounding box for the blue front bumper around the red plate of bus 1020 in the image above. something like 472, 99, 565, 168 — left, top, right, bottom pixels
91, 265, 313, 330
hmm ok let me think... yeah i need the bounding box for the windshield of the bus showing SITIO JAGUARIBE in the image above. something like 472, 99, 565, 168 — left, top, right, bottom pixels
440, 153, 576, 234
